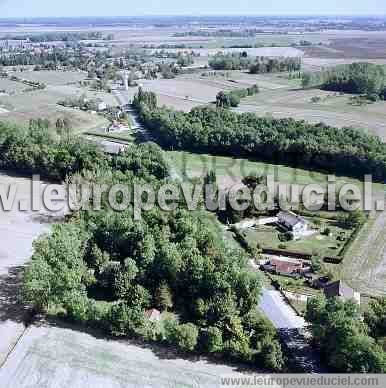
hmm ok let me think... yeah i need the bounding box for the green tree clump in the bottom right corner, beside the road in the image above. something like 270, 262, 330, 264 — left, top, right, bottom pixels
306, 297, 386, 373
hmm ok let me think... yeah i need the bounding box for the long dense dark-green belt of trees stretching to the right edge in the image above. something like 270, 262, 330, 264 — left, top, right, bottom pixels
136, 96, 386, 181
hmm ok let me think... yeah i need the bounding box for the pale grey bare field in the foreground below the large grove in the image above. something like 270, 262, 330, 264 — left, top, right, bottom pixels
0, 325, 257, 388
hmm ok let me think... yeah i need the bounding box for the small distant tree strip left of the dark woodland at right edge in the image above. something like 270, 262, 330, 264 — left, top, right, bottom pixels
209, 51, 301, 74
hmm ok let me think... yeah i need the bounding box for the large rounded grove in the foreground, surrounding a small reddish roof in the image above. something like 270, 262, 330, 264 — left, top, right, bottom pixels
25, 205, 283, 369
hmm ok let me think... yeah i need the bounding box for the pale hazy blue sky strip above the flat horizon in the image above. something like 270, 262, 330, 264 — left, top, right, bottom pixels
0, 0, 386, 18
